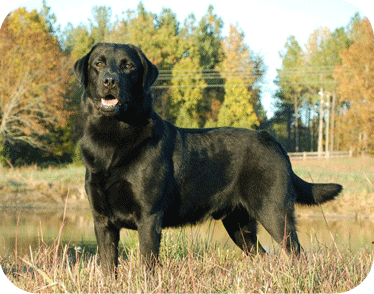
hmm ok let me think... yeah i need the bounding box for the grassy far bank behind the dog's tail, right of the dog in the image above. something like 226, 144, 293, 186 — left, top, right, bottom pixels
292, 157, 374, 219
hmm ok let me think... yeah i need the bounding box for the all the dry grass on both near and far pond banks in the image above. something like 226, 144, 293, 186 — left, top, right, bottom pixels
0, 158, 374, 293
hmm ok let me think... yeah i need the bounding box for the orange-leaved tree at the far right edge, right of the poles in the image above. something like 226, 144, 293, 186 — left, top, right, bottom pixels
334, 18, 374, 151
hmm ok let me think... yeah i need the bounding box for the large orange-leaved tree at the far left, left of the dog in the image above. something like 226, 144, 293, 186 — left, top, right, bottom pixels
0, 8, 69, 163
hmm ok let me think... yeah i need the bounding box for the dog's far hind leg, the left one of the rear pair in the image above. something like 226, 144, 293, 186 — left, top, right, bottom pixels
222, 209, 266, 254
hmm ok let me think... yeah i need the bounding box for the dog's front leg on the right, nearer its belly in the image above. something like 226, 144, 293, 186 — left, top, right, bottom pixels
138, 212, 163, 268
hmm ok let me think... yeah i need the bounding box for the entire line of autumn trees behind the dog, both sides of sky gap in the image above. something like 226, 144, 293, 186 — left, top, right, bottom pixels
0, 2, 374, 165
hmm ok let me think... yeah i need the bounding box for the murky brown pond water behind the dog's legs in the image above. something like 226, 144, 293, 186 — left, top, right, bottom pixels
0, 209, 374, 257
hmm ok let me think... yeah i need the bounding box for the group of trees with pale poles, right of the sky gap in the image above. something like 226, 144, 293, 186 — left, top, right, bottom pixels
272, 14, 374, 154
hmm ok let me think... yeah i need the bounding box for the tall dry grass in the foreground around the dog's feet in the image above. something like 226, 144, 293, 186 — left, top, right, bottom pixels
0, 224, 374, 293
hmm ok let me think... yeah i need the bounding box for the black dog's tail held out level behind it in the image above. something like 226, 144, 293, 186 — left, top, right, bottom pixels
292, 172, 343, 205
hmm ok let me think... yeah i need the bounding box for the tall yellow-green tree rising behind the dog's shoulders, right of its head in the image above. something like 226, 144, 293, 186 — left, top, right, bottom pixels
170, 5, 223, 127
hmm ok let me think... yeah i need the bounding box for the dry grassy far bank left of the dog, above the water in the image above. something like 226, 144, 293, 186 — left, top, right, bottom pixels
0, 165, 88, 209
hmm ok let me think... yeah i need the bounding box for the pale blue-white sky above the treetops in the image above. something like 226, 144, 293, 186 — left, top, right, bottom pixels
0, 0, 374, 118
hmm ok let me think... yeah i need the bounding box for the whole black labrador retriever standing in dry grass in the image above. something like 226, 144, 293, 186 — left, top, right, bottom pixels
74, 43, 342, 269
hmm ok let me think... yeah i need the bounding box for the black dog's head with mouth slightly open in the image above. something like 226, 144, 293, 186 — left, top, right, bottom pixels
74, 43, 158, 116
